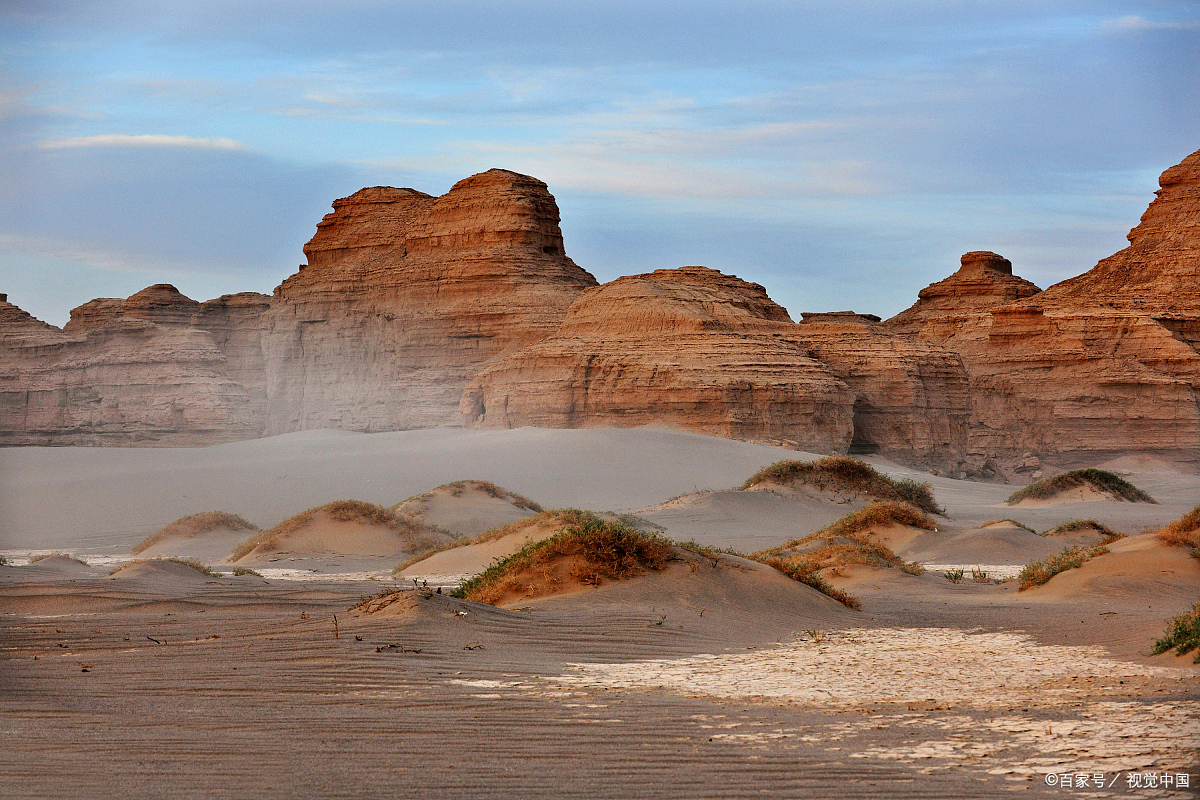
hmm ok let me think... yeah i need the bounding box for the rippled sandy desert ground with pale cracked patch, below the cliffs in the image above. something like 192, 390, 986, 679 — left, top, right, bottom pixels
0, 428, 1200, 798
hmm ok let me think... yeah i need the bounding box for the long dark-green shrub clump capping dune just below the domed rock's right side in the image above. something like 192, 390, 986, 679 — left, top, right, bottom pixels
742, 456, 944, 515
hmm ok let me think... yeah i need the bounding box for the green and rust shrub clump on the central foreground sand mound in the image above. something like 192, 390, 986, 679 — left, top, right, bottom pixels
451, 510, 674, 603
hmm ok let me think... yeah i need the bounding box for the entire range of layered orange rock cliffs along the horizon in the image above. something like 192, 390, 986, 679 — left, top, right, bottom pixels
7, 152, 1200, 477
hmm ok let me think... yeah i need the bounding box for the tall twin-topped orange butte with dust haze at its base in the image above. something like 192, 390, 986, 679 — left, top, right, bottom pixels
264, 169, 595, 433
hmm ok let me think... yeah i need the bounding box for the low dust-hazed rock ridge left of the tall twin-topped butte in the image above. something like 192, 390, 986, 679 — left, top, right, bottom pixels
0, 284, 265, 445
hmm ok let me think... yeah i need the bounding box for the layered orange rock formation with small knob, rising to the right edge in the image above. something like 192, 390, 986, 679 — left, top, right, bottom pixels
884, 152, 1200, 471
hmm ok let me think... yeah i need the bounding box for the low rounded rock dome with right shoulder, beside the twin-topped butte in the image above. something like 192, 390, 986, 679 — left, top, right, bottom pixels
462, 266, 967, 455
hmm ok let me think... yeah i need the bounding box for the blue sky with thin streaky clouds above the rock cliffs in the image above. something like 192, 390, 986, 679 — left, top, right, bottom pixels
0, 0, 1200, 324
